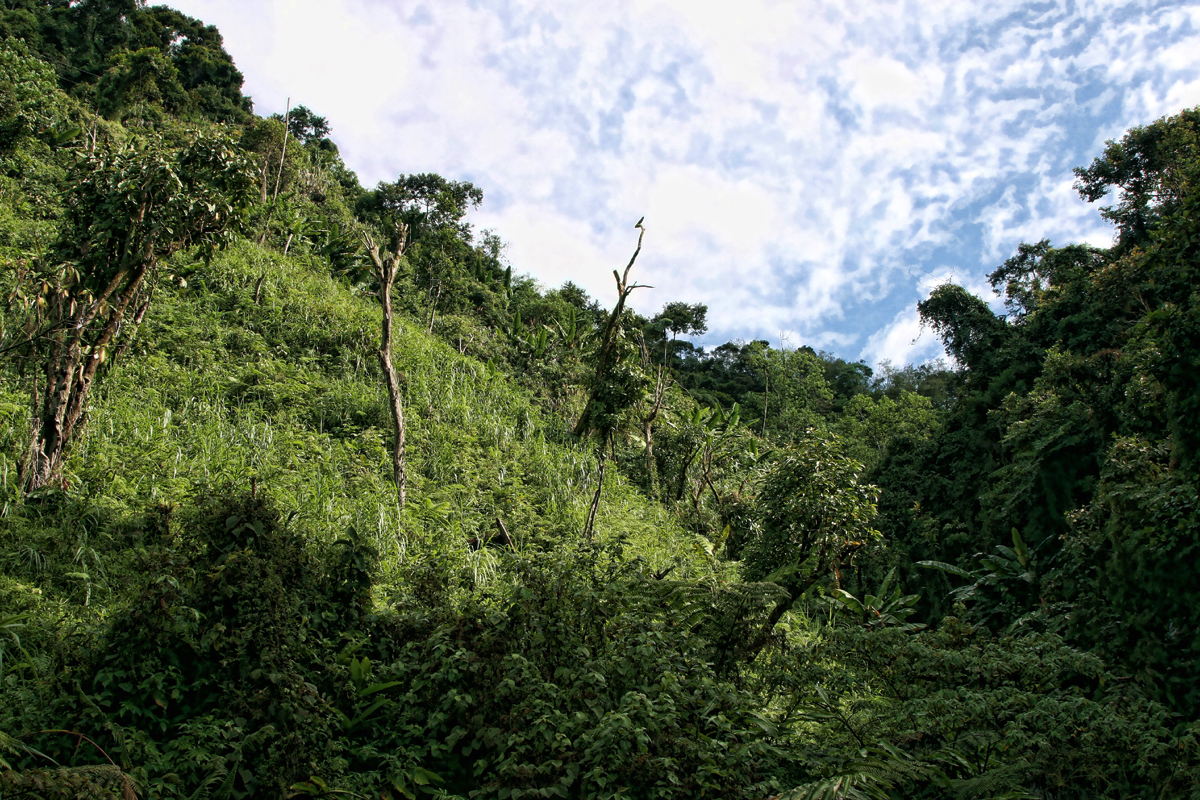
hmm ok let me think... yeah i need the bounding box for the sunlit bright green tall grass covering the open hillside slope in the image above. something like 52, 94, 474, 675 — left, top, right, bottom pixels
0, 237, 700, 614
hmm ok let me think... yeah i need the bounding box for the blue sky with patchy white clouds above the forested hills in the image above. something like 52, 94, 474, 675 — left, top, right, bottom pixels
167, 0, 1200, 366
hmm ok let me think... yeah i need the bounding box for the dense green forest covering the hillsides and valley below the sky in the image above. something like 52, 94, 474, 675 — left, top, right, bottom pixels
0, 0, 1200, 800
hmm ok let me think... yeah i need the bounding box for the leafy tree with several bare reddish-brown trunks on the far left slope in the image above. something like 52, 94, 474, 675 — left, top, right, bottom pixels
22, 137, 252, 489
